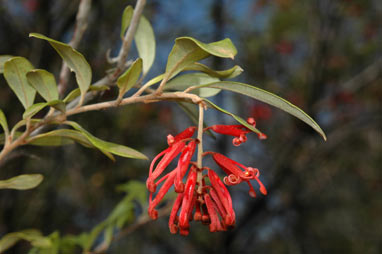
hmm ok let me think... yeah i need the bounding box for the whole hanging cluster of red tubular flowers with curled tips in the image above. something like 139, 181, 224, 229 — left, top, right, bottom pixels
146, 121, 267, 235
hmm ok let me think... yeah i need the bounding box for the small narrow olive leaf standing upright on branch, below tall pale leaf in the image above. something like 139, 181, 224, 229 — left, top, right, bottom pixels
117, 58, 142, 98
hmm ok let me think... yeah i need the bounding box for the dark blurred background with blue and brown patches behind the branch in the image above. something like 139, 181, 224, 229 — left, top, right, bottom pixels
0, 0, 382, 254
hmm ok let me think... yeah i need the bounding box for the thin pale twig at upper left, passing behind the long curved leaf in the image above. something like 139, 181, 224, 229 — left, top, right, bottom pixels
58, 0, 92, 97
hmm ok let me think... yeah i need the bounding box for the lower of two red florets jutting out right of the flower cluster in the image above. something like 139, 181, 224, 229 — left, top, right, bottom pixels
209, 152, 267, 197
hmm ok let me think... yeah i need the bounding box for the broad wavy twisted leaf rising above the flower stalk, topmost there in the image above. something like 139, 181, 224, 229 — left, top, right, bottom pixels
166, 37, 237, 80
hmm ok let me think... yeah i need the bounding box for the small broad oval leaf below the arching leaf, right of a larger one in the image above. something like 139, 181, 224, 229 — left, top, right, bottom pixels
27, 69, 58, 101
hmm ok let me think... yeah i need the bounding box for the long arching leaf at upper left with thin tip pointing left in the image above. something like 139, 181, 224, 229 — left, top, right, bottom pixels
29, 33, 92, 101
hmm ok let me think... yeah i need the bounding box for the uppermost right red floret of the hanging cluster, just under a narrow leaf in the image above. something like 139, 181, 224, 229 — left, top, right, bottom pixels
204, 117, 267, 146
